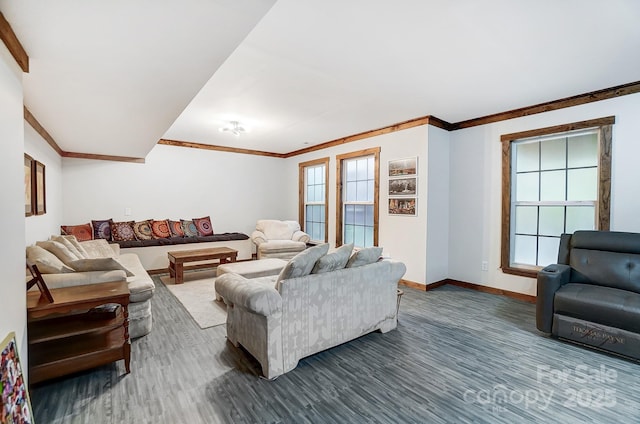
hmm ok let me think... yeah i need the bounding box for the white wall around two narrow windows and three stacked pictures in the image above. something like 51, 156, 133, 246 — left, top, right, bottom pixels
286, 126, 432, 284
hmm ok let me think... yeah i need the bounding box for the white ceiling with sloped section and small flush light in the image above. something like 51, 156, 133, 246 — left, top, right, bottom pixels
0, 0, 640, 157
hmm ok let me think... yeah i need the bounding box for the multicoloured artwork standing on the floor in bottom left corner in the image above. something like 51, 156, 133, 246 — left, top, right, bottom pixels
0, 332, 33, 423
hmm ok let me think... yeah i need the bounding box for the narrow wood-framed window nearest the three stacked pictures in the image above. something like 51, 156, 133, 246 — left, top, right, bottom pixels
336, 147, 380, 247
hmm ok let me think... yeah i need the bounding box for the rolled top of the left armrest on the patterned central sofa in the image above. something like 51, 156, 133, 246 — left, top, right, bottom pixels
216, 272, 282, 317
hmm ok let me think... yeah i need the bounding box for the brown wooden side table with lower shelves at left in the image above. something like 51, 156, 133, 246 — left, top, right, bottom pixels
27, 280, 131, 384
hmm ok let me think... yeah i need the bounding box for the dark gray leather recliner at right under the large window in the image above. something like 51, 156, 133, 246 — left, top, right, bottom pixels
536, 231, 640, 359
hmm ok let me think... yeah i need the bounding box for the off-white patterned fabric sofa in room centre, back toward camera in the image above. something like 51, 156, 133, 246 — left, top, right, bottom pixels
215, 245, 406, 379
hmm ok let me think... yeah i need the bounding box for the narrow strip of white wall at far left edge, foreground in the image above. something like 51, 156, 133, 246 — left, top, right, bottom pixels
0, 43, 27, 362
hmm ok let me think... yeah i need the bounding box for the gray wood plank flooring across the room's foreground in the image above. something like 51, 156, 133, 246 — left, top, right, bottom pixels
31, 276, 640, 424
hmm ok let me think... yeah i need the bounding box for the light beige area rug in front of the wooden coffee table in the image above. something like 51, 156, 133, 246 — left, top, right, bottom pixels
159, 271, 227, 328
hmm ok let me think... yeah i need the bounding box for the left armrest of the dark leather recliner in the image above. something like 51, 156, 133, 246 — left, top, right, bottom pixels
536, 264, 571, 333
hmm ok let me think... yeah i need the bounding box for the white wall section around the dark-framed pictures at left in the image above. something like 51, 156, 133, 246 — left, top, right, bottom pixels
24, 121, 62, 245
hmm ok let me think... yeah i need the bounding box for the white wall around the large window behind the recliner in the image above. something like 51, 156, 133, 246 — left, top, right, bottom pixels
449, 94, 640, 295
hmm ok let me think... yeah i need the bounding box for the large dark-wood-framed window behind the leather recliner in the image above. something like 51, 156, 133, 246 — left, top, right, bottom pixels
502, 117, 614, 277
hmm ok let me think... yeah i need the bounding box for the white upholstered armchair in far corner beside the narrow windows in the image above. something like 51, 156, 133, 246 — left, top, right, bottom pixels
251, 219, 310, 260
